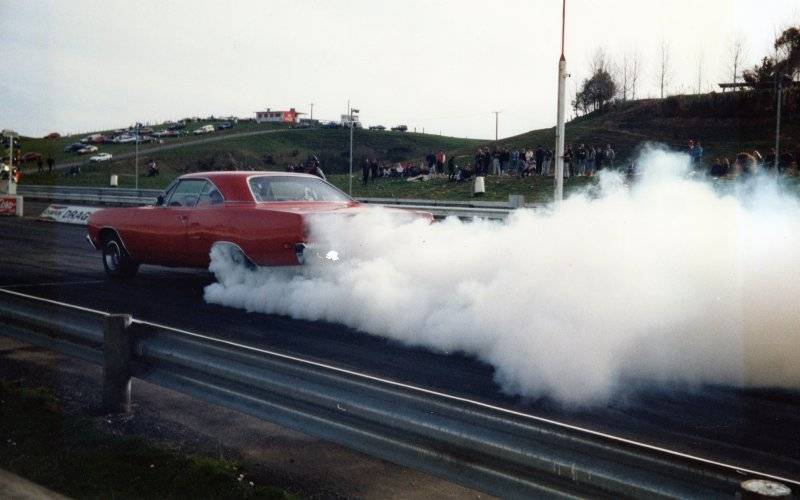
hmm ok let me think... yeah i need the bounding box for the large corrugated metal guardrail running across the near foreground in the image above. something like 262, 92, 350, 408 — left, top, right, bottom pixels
0, 289, 800, 498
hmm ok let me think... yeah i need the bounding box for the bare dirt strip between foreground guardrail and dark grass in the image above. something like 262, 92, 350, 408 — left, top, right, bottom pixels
0, 337, 487, 499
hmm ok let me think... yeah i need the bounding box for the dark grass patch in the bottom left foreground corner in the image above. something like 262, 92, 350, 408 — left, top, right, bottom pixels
0, 381, 293, 499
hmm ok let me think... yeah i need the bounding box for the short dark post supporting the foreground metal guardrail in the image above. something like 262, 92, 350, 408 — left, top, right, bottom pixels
103, 314, 133, 413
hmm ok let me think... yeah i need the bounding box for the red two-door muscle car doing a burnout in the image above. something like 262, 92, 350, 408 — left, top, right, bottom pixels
87, 171, 433, 279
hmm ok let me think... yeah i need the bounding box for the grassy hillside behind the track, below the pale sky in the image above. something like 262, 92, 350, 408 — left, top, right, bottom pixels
12, 89, 800, 201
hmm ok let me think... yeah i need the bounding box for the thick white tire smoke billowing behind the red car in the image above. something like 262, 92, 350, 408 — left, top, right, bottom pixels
205, 146, 800, 404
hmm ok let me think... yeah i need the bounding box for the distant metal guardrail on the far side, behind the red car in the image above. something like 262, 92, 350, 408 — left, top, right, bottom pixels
17, 184, 513, 219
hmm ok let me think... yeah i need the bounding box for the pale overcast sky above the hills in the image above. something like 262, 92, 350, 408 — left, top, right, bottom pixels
0, 0, 800, 138
